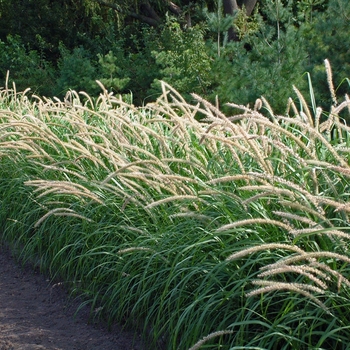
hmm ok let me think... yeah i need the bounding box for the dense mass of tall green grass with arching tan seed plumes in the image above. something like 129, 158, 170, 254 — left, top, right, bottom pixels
0, 61, 350, 349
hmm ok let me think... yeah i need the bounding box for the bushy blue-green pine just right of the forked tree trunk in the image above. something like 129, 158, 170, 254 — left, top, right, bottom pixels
211, 1, 306, 113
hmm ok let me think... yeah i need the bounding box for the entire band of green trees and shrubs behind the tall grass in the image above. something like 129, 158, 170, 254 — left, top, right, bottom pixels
0, 0, 350, 112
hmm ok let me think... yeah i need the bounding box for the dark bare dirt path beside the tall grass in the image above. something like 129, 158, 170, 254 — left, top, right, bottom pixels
0, 246, 145, 350
